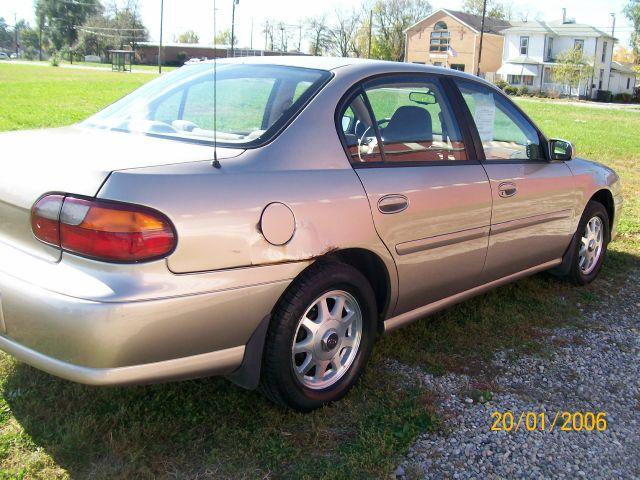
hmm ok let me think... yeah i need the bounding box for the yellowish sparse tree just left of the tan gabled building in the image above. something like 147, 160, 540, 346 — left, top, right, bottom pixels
372, 0, 431, 62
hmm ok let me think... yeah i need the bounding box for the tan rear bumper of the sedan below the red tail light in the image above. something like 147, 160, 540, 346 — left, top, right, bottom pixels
0, 244, 305, 385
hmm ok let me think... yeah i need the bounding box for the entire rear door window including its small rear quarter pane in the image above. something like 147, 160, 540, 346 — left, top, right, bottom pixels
341, 77, 467, 164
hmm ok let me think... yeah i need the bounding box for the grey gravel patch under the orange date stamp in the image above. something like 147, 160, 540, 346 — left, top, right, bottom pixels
394, 271, 640, 479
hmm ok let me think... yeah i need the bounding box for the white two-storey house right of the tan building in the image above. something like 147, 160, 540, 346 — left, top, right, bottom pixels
497, 15, 635, 98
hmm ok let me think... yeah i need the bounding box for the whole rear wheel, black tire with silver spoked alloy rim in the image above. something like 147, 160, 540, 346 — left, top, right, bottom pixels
260, 262, 377, 412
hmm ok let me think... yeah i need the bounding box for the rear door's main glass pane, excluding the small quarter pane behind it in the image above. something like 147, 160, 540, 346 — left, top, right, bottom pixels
350, 78, 467, 163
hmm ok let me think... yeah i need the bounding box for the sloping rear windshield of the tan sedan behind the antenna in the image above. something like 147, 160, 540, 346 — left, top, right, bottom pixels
83, 63, 331, 147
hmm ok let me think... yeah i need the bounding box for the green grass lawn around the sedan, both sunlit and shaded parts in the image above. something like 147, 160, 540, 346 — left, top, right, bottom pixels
0, 64, 640, 479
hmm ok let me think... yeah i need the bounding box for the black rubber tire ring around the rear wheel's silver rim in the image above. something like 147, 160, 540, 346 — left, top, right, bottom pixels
259, 261, 377, 412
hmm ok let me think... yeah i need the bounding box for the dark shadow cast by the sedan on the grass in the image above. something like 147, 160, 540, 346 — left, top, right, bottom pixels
0, 252, 640, 478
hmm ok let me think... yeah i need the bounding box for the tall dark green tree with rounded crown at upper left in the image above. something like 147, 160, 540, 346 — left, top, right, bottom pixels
35, 0, 103, 50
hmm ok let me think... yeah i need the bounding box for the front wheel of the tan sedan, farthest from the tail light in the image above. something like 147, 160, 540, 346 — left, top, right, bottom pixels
566, 201, 610, 285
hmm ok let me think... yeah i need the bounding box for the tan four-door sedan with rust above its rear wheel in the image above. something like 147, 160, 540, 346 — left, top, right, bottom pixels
0, 57, 622, 411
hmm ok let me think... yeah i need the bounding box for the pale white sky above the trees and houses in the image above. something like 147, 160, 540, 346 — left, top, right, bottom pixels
0, 0, 631, 48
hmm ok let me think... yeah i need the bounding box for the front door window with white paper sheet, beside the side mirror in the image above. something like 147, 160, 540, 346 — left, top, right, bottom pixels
456, 80, 544, 160
